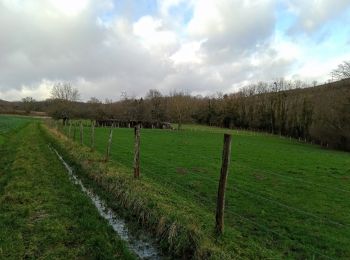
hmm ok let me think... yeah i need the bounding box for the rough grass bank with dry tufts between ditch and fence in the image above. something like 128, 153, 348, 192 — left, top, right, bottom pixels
41, 123, 226, 259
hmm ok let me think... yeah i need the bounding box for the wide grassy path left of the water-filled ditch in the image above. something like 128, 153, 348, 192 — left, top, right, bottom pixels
0, 123, 133, 259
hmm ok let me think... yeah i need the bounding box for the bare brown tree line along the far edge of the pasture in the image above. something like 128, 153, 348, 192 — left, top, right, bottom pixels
0, 62, 350, 150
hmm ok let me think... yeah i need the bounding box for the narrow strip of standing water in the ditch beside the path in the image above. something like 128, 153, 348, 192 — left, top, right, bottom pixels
49, 145, 162, 259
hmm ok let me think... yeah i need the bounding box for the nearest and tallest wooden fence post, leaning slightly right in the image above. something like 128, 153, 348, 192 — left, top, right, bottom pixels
215, 134, 232, 234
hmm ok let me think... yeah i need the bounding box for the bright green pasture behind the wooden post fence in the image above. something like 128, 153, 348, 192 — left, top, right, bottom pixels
61, 122, 350, 259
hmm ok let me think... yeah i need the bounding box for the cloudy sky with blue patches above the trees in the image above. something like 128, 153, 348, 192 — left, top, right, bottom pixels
0, 0, 350, 101
